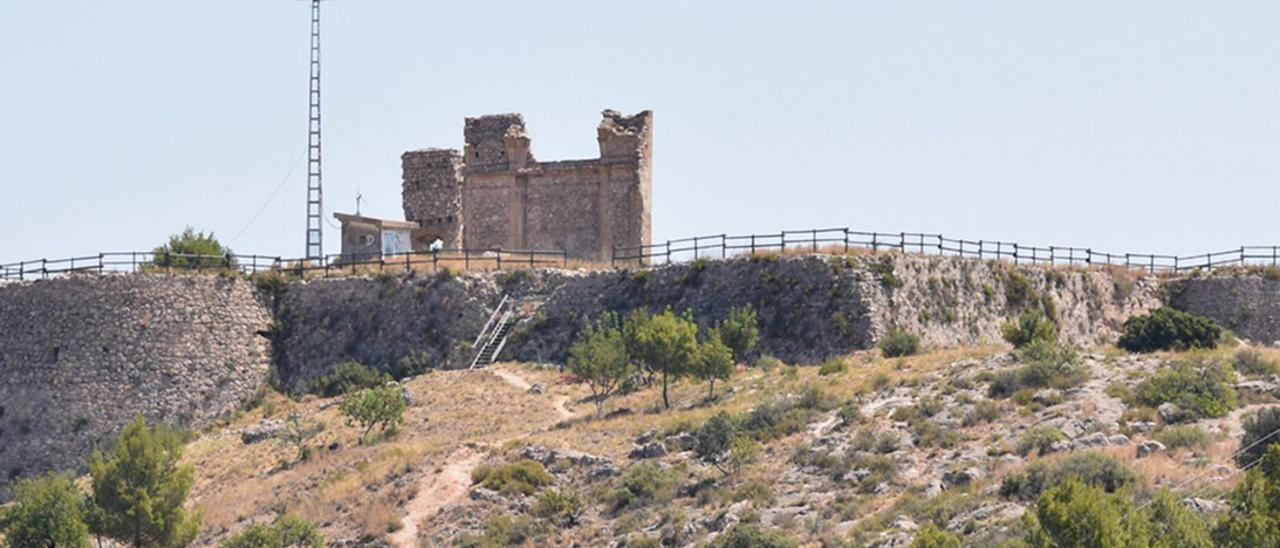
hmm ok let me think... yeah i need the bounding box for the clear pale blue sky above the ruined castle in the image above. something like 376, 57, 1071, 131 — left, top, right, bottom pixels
0, 0, 1280, 261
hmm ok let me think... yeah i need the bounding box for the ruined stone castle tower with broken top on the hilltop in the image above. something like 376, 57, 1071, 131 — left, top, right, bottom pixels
401, 110, 653, 260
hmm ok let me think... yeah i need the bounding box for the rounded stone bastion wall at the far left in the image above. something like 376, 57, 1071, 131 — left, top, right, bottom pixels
0, 274, 271, 494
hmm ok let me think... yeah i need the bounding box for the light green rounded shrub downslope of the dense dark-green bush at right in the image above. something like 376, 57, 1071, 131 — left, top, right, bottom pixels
1135, 356, 1236, 419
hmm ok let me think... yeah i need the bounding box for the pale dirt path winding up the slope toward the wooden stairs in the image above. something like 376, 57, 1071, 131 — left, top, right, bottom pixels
388, 367, 573, 548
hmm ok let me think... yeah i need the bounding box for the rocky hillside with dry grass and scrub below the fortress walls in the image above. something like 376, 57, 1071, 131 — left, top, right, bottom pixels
172, 347, 1280, 547
